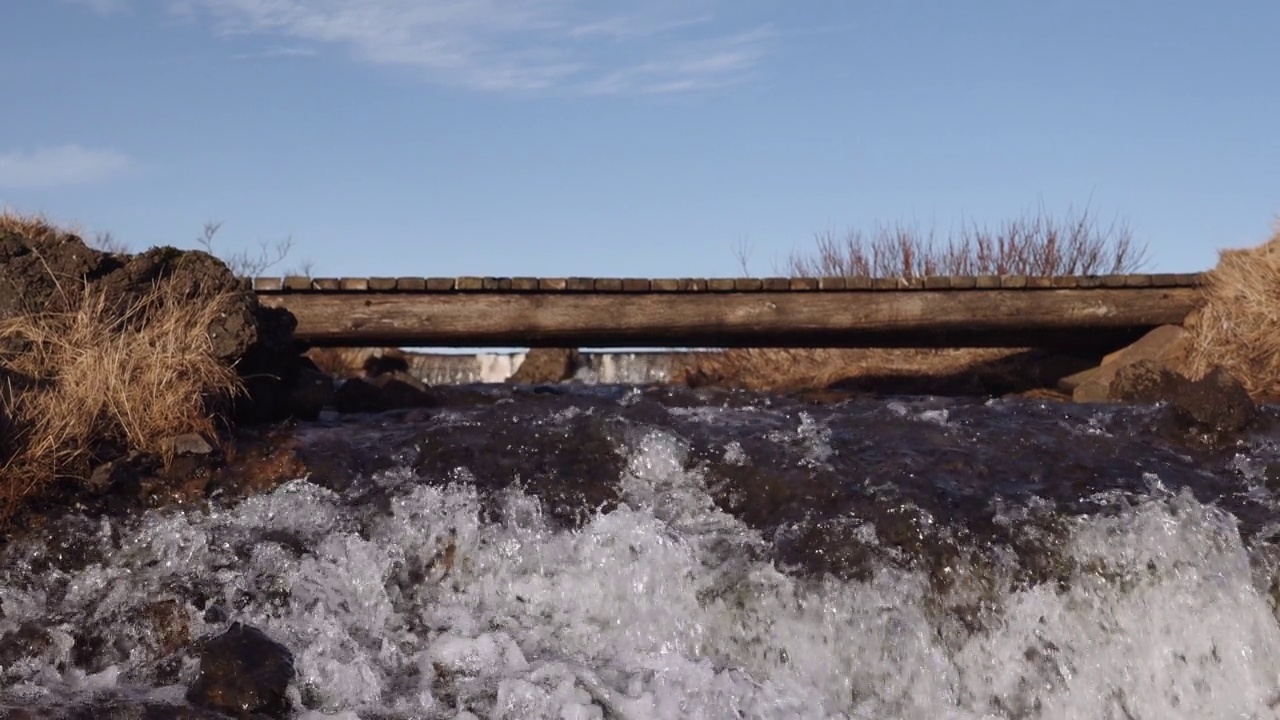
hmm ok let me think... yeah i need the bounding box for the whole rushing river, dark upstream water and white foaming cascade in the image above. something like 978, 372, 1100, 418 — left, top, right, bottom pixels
0, 387, 1280, 720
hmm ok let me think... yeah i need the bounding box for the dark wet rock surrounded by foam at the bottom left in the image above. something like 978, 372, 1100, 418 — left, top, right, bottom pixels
187, 623, 294, 717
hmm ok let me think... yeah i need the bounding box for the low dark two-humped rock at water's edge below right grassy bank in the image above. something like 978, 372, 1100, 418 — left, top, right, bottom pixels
1111, 360, 1258, 433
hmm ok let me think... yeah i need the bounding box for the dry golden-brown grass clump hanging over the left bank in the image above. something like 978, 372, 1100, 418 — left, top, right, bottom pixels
0, 278, 241, 520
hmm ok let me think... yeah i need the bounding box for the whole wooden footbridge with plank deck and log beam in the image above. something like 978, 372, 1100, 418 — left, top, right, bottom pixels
251, 274, 1201, 348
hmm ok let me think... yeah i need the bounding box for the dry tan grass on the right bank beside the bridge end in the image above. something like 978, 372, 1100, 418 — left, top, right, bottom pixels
1187, 223, 1280, 400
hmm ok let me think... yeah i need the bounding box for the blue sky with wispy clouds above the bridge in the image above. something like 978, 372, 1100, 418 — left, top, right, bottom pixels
0, 0, 1280, 277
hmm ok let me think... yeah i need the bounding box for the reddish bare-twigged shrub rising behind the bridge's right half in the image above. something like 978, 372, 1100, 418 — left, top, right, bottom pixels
788, 208, 1147, 278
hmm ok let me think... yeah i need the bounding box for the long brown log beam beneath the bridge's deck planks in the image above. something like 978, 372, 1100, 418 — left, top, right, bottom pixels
259, 287, 1199, 348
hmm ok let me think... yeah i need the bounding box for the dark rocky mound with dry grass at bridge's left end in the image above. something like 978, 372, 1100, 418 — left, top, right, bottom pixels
0, 214, 307, 520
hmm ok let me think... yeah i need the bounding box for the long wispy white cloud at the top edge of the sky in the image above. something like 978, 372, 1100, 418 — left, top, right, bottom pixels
94, 0, 772, 95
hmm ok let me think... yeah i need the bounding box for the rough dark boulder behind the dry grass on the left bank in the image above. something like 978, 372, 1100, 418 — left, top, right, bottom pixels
0, 215, 298, 423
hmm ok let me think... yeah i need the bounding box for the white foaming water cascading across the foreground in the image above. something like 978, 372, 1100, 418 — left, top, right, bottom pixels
0, 432, 1280, 720
